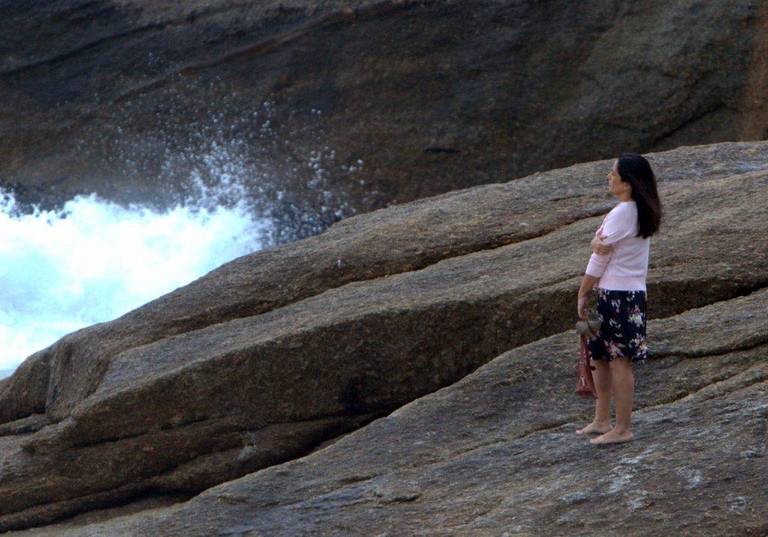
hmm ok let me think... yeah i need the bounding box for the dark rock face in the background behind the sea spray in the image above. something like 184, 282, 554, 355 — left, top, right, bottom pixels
0, 0, 768, 242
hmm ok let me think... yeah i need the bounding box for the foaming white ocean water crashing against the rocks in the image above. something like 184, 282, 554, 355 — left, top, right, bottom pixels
0, 177, 272, 378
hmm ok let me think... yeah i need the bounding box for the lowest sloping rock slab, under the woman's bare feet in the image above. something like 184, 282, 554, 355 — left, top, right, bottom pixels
12, 289, 768, 537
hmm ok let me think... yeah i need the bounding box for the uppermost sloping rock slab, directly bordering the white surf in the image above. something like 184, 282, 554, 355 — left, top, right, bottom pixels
0, 142, 768, 422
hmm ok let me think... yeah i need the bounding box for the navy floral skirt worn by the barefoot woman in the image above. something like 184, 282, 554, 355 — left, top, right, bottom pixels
587, 287, 648, 365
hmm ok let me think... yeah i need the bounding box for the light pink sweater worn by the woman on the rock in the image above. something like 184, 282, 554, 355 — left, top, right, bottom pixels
586, 201, 651, 291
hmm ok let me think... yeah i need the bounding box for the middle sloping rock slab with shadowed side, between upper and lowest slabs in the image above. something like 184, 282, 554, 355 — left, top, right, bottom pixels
0, 140, 768, 528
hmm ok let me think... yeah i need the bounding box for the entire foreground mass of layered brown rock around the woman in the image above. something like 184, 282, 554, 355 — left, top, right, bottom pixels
0, 142, 768, 535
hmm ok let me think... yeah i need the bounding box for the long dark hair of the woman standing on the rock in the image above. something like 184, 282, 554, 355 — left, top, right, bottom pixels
616, 153, 662, 238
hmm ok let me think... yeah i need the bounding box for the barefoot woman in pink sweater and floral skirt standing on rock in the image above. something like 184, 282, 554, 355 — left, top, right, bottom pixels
576, 153, 662, 444
